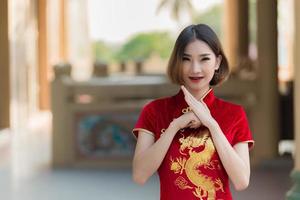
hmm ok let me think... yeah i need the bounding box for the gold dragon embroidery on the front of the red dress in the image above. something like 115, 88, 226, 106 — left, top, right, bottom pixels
170, 129, 224, 200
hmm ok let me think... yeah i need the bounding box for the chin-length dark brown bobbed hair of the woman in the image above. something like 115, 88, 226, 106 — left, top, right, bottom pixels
167, 24, 229, 86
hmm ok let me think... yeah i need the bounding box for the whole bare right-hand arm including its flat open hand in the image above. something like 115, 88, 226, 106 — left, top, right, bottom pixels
182, 86, 250, 190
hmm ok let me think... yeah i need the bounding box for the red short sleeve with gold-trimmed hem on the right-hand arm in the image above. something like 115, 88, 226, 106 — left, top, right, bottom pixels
232, 107, 254, 149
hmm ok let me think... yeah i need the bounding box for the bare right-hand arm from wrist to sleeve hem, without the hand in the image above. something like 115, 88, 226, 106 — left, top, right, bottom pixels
208, 122, 250, 190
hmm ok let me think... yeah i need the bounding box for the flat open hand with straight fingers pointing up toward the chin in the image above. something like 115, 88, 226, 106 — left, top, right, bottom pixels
181, 86, 215, 127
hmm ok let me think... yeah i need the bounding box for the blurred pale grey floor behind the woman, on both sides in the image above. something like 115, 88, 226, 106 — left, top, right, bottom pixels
0, 114, 293, 200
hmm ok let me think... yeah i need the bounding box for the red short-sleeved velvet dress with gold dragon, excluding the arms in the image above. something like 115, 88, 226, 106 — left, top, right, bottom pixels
133, 90, 254, 200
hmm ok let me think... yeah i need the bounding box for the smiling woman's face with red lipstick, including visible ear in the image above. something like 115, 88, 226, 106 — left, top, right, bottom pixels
182, 40, 222, 92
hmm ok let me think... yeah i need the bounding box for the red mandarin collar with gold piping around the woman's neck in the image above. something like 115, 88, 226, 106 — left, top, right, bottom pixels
175, 88, 215, 108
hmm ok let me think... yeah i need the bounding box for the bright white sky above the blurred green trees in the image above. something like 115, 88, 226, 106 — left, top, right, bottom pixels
88, 0, 222, 43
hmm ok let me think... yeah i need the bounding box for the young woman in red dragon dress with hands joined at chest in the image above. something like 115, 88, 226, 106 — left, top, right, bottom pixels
133, 24, 254, 200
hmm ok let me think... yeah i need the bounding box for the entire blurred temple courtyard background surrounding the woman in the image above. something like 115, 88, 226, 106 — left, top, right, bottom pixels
0, 0, 300, 200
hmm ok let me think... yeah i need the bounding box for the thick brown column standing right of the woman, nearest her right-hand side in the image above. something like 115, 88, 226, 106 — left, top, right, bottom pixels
252, 0, 279, 164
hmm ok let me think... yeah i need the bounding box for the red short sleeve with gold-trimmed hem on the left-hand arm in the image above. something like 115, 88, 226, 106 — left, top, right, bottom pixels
132, 102, 155, 138
